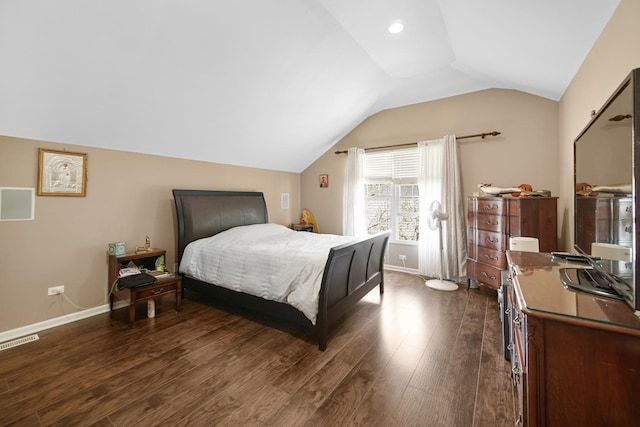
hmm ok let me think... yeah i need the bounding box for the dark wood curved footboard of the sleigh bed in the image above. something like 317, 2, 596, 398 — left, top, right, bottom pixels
316, 231, 391, 351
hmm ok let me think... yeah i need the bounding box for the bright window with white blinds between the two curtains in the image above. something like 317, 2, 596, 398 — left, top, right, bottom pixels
364, 149, 420, 242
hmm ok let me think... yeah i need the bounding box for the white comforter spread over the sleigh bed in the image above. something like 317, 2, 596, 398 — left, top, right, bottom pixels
180, 224, 354, 325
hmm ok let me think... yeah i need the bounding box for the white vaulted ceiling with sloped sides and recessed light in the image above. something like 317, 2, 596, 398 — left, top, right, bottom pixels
0, 0, 620, 172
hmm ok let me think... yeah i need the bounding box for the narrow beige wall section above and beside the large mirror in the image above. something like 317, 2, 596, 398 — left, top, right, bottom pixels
559, 0, 640, 250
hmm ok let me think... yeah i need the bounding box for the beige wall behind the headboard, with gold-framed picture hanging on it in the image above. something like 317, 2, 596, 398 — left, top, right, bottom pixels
0, 136, 300, 332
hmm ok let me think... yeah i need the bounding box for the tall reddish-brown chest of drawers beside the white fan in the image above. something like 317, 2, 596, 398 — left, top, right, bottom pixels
467, 196, 558, 289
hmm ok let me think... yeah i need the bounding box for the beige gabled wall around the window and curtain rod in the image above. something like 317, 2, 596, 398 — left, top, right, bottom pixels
301, 89, 559, 241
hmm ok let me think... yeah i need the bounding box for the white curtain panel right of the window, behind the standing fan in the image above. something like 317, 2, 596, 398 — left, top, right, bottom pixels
418, 135, 467, 279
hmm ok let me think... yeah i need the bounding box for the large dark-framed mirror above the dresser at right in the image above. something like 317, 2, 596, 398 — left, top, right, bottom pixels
574, 72, 639, 309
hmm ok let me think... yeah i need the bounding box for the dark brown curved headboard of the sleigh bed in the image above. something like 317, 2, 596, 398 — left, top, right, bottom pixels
173, 190, 269, 263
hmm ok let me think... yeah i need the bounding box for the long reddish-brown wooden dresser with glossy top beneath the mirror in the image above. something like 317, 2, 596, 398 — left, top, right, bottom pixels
508, 251, 640, 427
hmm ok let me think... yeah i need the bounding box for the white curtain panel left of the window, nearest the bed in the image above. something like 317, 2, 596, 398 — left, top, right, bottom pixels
342, 147, 367, 236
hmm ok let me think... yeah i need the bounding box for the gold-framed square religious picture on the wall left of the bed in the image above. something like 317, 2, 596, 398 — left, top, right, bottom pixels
38, 148, 87, 197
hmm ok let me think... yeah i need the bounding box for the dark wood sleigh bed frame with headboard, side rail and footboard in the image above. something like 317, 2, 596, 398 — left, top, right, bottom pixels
173, 190, 391, 350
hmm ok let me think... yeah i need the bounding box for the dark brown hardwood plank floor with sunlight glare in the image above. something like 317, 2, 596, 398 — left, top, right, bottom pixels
0, 271, 515, 427
